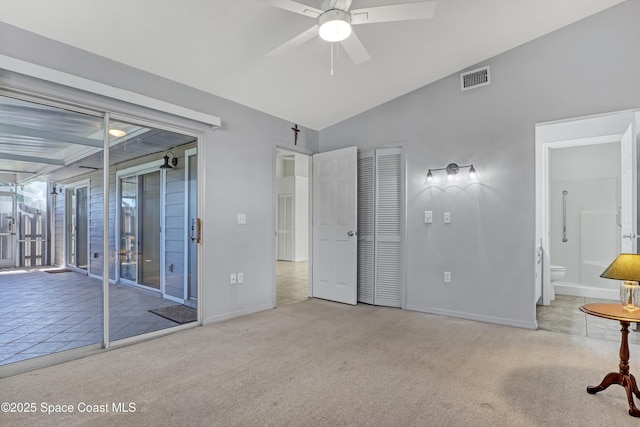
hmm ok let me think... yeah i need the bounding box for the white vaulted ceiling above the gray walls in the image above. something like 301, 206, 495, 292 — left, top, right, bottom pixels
0, 0, 623, 130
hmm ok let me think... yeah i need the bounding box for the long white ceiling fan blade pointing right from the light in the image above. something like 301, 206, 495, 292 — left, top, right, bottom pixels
351, 1, 438, 25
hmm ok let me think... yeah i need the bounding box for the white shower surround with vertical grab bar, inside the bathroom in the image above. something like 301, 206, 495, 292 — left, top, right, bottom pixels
549, 143, 620, 299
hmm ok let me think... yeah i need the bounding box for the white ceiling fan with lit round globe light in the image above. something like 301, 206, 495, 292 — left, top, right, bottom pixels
267, 0, 437, 65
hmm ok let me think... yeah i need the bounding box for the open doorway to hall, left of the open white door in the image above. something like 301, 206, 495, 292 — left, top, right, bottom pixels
274, 148, 310, 306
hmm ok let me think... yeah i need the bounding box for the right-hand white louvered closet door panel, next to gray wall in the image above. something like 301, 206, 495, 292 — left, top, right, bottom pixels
374, 148, 403, 307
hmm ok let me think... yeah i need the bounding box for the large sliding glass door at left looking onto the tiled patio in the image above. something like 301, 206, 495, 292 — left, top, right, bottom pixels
0, 91, 199, 367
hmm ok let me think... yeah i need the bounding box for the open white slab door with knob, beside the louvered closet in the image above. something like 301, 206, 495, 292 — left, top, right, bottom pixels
312, 147, 358, 305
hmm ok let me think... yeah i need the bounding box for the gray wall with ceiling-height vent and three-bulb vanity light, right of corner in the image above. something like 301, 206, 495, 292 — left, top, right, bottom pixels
320, 0, 640, 327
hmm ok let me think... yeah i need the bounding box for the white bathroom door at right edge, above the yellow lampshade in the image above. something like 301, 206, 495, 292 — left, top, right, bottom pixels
618, 124, 637, 254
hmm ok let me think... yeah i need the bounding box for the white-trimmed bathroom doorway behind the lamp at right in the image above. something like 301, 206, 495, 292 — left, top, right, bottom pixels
536, 111, 640, 306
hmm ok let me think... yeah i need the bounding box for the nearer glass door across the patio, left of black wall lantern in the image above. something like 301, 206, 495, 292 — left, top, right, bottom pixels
120, 171, 160, 289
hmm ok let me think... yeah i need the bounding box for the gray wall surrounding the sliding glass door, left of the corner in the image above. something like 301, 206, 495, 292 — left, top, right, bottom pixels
0, 23, 318, 321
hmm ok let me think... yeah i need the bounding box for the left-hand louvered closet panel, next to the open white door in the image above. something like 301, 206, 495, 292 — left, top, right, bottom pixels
358, 151, 375, 304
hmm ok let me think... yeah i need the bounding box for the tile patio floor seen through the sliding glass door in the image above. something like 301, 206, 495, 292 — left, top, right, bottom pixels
0, 270, 185, 365
